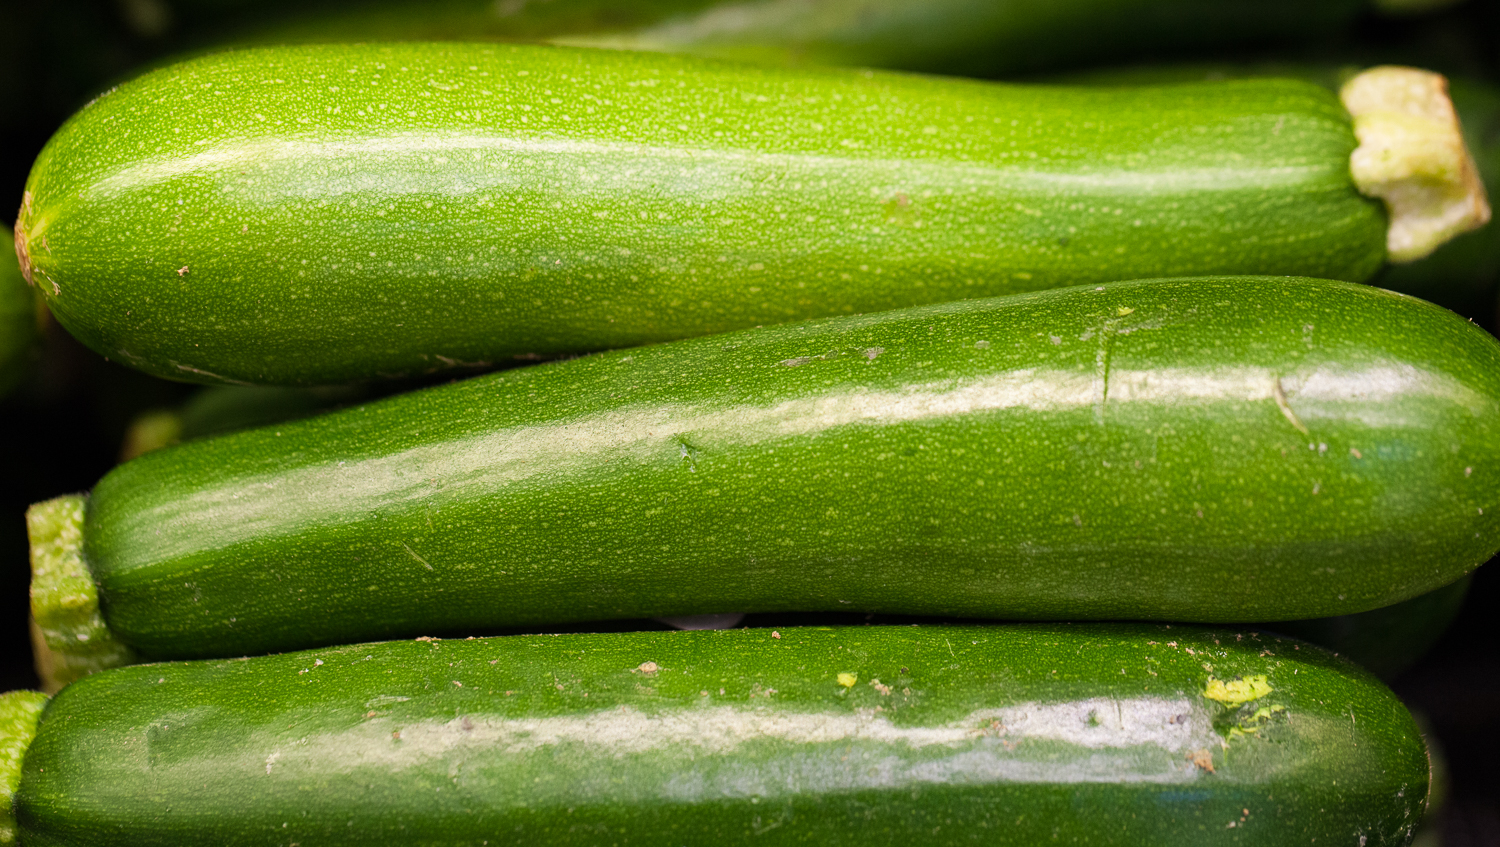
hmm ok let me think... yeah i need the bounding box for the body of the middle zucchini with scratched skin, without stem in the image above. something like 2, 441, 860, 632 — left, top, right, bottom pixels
81, 277, 1500, 658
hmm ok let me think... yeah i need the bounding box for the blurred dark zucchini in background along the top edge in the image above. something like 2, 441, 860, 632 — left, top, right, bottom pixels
198, 0, 1400, 76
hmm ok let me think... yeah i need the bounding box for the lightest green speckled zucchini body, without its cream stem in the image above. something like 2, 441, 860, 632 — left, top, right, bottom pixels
18, 43, 1386, 384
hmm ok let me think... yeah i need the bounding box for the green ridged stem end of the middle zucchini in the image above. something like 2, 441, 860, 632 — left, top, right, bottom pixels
26, 495, 135, 693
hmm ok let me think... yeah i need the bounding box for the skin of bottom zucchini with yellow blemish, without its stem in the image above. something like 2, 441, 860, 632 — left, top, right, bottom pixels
8, 625, 1428, 847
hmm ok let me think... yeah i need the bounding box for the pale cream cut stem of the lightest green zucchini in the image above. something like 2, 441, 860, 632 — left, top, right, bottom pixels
1340, 66, 1490, 262
